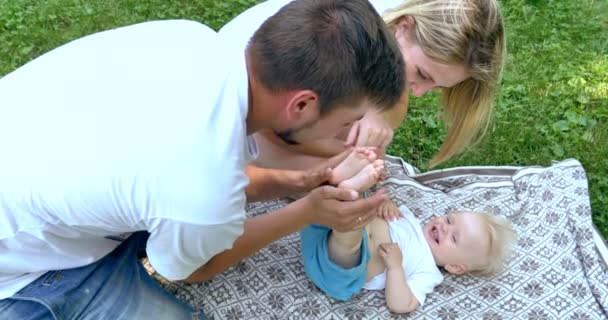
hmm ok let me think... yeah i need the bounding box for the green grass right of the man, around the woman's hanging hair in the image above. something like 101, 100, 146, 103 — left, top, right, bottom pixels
389, 0, 608, 237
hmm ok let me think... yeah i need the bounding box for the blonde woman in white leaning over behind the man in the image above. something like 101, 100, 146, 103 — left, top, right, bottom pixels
219, 0, 505, 175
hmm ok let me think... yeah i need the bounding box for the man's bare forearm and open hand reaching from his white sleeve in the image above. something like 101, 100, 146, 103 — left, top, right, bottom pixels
184, 186, 387, 283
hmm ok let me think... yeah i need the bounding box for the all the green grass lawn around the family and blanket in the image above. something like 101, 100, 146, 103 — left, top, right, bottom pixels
0, 0, 608, 237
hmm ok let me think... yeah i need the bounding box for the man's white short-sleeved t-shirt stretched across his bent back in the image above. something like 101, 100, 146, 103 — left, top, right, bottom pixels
0, 20, 257, 299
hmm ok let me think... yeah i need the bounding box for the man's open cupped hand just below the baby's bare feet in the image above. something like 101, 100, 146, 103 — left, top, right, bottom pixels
299, 186, 388, 232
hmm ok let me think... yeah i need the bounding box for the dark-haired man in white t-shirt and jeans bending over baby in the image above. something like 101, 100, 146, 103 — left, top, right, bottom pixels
0, 0, 404, 319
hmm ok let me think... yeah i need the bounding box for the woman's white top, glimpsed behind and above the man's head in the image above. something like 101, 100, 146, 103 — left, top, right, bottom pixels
218, 0, 406, 50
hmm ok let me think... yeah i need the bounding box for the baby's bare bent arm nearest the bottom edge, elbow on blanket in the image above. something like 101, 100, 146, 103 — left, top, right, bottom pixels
378, 243, 419, 313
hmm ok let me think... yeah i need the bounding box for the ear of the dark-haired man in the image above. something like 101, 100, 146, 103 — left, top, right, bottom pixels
285, 90, 320, 124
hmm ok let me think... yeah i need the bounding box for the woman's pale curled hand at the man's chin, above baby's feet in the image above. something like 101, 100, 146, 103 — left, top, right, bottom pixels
345, 110, 393, 150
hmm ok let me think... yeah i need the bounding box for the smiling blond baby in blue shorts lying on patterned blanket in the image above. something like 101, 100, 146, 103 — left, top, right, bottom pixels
300, 150, 515, 313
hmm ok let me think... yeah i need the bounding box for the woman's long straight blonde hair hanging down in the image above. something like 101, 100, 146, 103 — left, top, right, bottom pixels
383, 0, 506, 167
